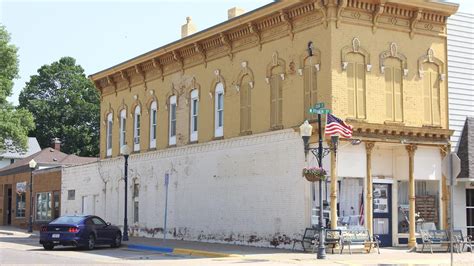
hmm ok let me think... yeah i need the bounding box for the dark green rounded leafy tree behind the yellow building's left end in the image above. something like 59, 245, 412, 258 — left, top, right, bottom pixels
19, 57, 100, 156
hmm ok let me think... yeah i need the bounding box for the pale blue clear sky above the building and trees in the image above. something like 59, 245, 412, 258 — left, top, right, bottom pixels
0, 0, 474, 105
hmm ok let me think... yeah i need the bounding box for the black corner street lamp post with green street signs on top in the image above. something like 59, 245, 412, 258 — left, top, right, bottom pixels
300, 119, 339, 259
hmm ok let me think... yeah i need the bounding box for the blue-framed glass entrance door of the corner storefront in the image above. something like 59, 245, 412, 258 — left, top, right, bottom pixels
373, 183, 392, 247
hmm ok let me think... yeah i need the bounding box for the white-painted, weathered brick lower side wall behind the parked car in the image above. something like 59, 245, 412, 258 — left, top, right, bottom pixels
61, 129, 311, 247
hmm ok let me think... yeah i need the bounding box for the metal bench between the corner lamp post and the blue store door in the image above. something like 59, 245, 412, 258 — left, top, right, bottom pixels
340, 229, 380, 254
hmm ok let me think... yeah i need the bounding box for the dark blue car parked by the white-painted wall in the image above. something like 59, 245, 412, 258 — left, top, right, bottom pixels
39, 215, 122, 250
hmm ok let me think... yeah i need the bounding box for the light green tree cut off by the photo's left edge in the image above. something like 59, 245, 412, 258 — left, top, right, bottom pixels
0, 25, 34, 154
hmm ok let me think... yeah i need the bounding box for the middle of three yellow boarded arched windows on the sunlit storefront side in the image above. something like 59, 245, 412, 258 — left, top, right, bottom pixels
384, 58, 403, 122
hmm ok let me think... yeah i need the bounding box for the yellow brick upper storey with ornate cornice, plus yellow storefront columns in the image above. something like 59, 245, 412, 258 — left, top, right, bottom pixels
90, 0, 457, 248
